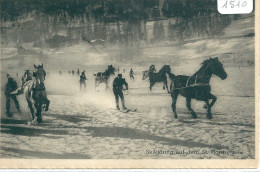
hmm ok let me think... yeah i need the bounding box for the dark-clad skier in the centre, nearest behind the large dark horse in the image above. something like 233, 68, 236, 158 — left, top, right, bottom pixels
113, 73, 128, 110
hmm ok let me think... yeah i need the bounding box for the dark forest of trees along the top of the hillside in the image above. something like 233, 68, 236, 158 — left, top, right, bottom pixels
1, 0, 244, 46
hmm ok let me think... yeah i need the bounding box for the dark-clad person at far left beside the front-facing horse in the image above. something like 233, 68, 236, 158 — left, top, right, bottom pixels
5, 74, 20, 117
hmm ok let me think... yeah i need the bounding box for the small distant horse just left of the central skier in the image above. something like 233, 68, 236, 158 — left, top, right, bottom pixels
94, 65, 115, 90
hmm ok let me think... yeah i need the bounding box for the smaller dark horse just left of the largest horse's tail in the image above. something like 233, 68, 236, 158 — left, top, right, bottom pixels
148, 65, 171, 93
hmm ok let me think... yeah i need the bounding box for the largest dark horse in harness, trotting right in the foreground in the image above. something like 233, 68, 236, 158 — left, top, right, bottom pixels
169, 57, 227, 119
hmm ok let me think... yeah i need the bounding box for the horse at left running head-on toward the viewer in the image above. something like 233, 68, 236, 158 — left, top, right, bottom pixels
14, 64, 50, 123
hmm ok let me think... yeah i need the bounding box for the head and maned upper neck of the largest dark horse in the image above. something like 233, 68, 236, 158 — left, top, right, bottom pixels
203, 57, 227, 80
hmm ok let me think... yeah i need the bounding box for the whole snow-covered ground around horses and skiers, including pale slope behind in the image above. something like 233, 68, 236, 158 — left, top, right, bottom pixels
0, 17, 255, 159
